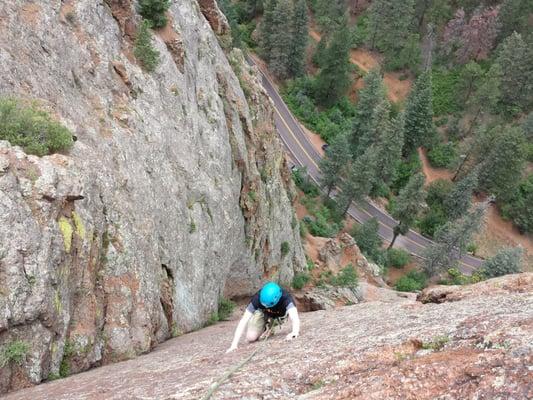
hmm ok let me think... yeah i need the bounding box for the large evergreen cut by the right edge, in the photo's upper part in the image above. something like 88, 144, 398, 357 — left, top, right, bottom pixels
496, 32, 533, 108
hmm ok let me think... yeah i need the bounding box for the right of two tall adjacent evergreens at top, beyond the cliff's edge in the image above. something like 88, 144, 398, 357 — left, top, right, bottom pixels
289, 0, 309, 77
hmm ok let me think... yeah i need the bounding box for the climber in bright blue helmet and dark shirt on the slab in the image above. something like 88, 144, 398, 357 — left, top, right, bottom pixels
226, 282, 300, 353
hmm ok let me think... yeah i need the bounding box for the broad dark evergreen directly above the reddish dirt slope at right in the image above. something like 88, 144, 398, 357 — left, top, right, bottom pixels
479, 127, 525, 201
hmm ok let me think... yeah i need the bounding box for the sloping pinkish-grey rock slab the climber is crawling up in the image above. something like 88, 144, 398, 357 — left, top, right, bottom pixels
5, 274, 533, 400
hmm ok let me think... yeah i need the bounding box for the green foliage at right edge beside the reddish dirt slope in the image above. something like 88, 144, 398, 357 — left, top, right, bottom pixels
502, 174, 533, 233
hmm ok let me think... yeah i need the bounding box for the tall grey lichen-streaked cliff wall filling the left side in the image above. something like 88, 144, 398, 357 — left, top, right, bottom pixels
0, 0, 305, 392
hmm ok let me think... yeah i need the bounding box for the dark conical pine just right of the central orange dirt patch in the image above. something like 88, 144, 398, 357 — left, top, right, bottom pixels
403, 71, 434, 155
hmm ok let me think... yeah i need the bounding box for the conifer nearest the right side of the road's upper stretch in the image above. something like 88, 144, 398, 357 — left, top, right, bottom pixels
320, 133, 351, 196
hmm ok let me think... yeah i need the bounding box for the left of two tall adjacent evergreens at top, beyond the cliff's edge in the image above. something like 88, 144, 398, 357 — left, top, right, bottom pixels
268, 0, 293, 79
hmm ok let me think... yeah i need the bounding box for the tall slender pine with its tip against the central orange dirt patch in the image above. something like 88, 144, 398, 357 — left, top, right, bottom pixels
350, 68, 386, 154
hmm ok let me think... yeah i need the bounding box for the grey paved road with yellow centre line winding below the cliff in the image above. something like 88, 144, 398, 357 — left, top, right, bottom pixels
248, 55, 482, 274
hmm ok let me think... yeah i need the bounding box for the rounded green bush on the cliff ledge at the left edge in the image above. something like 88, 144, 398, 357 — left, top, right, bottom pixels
0, 98, 73, 156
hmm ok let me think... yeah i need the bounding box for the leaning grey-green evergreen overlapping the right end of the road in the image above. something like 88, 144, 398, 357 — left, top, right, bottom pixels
423, 203, 488, 276
